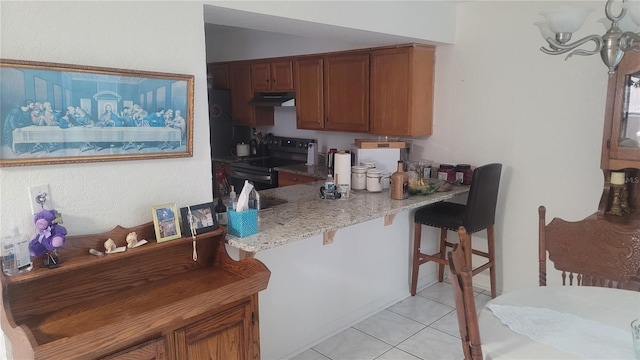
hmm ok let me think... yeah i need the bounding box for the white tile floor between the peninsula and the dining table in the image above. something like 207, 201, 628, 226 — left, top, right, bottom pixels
291, 282, 491, 360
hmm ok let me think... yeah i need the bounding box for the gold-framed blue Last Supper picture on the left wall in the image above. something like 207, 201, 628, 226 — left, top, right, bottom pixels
0, 59, 194, 166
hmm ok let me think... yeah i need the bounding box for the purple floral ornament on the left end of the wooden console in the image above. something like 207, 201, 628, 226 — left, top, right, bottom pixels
29, 209, 67, 268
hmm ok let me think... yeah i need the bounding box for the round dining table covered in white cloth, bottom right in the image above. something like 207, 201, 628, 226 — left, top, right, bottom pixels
478, 286, 640, 360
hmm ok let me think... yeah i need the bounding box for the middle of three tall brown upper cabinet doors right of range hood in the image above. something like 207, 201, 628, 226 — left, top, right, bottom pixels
324, 52, 369, 132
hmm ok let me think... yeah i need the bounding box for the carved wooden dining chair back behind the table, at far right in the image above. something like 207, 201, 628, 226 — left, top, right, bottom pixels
538, 206, 640, 291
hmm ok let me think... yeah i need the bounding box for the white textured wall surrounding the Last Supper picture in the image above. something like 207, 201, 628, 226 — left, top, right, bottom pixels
0, 1, 212, 234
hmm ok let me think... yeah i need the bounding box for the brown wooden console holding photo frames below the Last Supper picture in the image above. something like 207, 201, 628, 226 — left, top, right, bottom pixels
0, 223, 271, 360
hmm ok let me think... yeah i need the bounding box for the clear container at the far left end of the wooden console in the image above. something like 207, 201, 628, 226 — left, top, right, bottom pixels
2, 226, 33, 276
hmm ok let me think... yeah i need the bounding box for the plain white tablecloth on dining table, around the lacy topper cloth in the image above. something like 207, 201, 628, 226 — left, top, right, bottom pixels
479, 286, 640, 360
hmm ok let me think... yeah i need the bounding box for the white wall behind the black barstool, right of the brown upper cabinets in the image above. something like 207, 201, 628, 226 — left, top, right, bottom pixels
422, 1, 608, 292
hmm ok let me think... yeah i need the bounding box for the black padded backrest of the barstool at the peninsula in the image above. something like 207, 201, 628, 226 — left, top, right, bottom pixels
462, 163, 502, 234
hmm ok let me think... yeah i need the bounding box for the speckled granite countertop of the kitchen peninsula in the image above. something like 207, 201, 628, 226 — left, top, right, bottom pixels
227, 180, 469, 253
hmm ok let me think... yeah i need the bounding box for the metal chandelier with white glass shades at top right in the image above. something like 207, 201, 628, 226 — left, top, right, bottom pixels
535, 0, 640, 76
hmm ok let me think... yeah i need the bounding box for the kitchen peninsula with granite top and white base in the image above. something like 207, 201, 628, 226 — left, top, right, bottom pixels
227, 180, 469, 360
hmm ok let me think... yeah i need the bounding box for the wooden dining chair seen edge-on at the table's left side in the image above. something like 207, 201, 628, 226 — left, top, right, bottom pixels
449, 226, 482, 360
